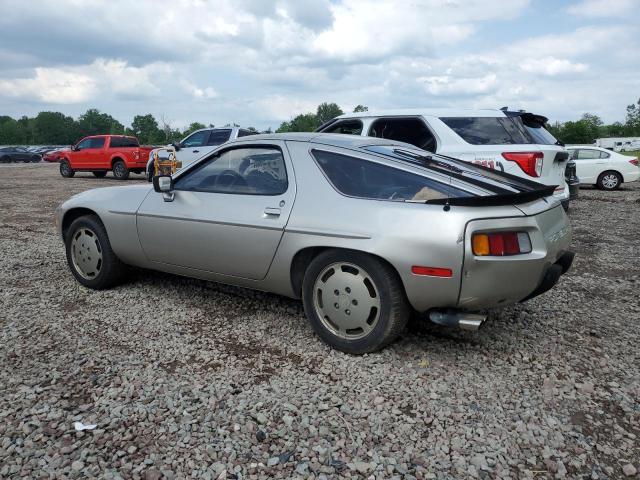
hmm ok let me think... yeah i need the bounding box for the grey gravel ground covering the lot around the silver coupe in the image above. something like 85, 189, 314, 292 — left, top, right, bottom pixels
0, 164, 640, 480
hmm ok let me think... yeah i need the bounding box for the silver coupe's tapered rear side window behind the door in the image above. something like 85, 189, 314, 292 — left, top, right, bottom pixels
312, 150, 469, 201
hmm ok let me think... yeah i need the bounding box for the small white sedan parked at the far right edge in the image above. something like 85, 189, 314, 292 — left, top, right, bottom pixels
567, 145, 640, 190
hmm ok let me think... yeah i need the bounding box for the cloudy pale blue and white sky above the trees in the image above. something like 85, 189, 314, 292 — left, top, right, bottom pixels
0, 0, 640, 128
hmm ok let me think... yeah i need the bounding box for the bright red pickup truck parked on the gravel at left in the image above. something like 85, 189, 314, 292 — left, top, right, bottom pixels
59, 135, 152, 180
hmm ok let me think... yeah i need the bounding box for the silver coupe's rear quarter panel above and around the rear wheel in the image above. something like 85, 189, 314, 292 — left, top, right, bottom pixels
266, 142, 522, 311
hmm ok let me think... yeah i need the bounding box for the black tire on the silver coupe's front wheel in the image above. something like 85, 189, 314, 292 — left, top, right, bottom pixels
64, 215, 127, 290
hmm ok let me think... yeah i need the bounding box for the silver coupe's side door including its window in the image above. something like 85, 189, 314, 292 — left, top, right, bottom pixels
137, 142, 295, 280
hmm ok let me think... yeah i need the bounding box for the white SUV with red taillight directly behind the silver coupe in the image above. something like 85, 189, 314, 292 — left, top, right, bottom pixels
317, 109, 569, 209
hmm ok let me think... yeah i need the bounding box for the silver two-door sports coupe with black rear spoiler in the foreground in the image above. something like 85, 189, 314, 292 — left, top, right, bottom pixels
56, 133, 573, 353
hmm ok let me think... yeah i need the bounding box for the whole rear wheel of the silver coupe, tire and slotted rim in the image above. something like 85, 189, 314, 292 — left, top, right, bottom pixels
302, 250, 410, 354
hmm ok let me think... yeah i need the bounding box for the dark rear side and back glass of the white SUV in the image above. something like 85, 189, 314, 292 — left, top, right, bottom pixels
440, 112, 558, 145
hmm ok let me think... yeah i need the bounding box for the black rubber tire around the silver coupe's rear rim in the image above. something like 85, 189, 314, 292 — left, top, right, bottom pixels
302, 250, 411, 355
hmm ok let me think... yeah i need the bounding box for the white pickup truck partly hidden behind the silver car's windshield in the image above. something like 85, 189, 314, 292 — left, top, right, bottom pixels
146, 127, 256, 181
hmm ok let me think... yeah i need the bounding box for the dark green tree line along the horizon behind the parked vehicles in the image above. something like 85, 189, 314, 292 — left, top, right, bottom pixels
0, 99, 640, 145
